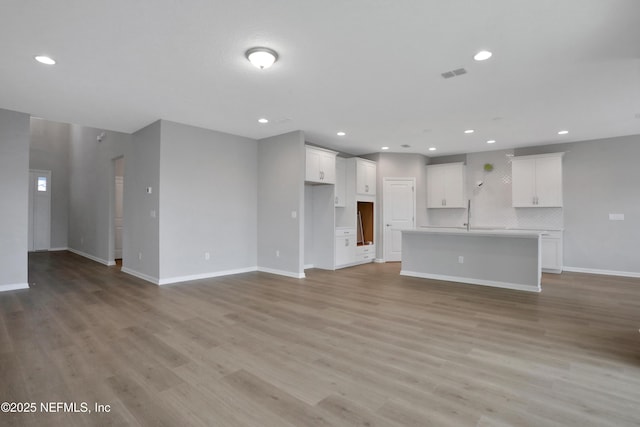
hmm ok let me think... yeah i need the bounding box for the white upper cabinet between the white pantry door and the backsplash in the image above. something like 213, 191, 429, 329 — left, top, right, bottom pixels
427, 163, 467, 208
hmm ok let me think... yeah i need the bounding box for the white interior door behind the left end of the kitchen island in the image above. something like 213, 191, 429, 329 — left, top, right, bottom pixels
382, 178, 416, 261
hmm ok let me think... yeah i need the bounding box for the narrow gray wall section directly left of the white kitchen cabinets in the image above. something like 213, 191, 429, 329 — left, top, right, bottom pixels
258, 131, 305, 277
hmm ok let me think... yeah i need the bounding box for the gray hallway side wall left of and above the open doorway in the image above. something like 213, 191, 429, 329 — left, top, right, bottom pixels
68, 125, 131, 264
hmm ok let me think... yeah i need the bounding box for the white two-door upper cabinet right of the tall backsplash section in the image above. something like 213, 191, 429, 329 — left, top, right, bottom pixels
511, 153, 564, 208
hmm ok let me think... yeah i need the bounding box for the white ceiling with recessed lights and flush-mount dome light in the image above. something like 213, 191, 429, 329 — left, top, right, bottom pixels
0, 0, 640, 155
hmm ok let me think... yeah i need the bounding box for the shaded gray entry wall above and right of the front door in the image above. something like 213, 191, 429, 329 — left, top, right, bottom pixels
29, 117, 71, 249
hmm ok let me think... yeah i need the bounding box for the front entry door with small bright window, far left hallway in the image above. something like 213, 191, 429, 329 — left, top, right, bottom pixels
29, 170, 51, 252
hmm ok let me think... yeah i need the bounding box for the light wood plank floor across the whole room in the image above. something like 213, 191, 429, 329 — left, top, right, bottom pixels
0, 252, 640, 427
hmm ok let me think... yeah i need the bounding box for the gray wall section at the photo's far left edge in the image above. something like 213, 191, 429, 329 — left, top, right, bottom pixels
0, 109, 29, 291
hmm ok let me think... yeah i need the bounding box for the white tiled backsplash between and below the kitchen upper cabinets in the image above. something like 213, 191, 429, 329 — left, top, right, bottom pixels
428, 150, 564, 229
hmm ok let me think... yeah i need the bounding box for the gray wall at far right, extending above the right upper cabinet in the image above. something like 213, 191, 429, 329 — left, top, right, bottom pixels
515, 135, 640, 275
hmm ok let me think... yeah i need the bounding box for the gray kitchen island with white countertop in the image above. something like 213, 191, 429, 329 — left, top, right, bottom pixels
400, 228, 542, 292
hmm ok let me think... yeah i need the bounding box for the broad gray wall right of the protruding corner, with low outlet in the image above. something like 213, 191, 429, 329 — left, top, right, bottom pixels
159, 120, 258, 283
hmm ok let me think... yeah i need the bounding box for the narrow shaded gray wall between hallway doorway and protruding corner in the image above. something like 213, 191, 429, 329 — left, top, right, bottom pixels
121, 120, 161, 283
